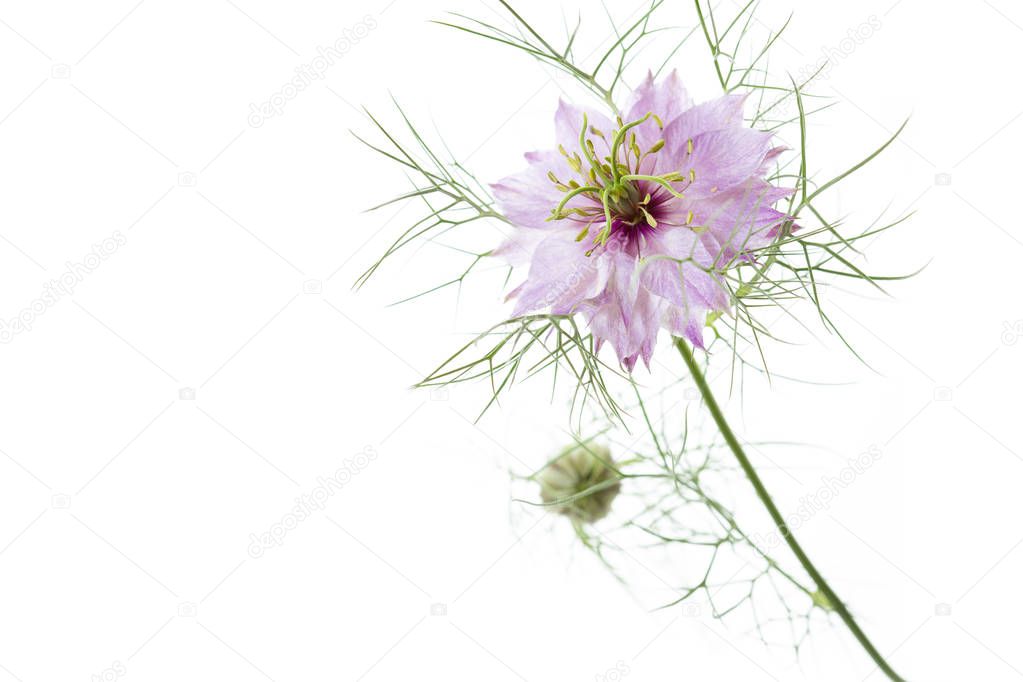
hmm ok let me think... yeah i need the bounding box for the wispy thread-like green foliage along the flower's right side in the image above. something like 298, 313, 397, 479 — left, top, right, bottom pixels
675, 0, 916, 375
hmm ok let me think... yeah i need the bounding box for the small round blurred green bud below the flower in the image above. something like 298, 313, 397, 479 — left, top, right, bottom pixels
536, 444, 621, 524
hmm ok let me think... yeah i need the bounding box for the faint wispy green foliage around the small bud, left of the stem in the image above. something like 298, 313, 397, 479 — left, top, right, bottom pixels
520, 380, 828, 649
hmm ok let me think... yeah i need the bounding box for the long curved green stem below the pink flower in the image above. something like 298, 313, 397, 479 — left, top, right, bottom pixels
675, 338, 904, 682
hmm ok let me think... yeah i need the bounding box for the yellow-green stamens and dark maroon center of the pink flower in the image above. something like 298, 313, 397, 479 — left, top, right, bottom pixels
547, 113, 696, 255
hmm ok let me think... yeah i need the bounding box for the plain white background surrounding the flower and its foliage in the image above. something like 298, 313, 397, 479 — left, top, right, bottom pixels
0, 0, 1023, 682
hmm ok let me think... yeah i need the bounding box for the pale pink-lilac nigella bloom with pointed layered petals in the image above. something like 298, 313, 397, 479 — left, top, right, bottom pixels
494, 73, 791, 370
